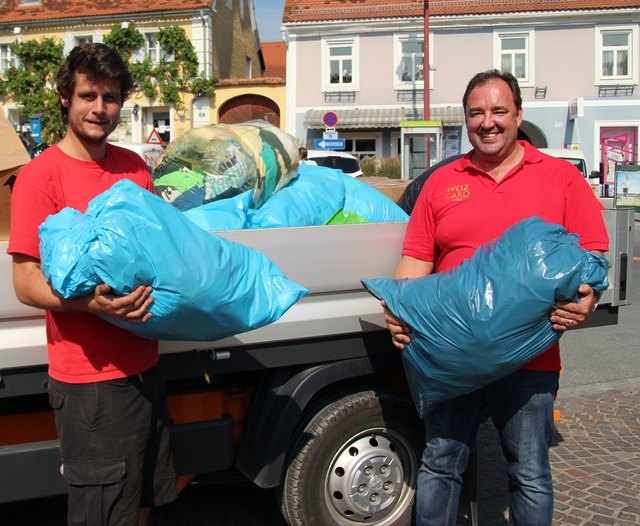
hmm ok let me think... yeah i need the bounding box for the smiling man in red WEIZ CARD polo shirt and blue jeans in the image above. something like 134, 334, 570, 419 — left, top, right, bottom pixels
383, 70, 608, 526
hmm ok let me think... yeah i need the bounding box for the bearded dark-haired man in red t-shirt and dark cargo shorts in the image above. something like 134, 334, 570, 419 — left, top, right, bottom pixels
8, 44, 176, 526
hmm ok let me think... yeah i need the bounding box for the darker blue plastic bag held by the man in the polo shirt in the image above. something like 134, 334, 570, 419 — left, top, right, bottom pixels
362, 217, 609, 416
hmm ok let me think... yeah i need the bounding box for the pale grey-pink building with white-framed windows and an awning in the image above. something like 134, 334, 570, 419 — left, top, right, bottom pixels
283, 0, 640, 182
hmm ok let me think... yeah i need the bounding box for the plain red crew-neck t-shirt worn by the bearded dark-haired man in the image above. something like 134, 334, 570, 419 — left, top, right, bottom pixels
7, 144, 158, 383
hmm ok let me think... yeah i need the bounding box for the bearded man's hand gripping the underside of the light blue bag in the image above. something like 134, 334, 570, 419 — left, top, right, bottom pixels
89, 283, 153, 323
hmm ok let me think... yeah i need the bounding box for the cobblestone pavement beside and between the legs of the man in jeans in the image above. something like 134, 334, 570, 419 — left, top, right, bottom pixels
470, 380, 640, 526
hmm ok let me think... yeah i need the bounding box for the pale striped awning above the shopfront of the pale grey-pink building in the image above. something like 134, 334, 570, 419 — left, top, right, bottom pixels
304, 106, 464, 129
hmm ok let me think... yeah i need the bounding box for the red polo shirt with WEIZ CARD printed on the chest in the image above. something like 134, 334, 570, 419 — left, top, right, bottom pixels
402, 142, 609, 371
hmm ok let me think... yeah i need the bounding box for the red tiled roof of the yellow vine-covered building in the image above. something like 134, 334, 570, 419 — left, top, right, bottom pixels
0, 0, 211, 24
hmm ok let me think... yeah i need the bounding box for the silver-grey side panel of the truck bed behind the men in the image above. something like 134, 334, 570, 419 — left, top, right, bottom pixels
0, 222, 406, 369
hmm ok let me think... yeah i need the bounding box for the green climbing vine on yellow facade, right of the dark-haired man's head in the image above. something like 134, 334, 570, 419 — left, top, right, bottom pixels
104, 23, 216, 109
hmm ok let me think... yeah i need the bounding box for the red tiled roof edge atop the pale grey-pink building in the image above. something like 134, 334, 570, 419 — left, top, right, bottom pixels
283, 0, 640, 23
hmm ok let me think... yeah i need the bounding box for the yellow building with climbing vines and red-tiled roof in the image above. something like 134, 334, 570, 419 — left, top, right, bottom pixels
0, 0, 264, 143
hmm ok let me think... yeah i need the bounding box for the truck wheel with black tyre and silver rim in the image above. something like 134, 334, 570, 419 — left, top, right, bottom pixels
279, 391, 423, 526
